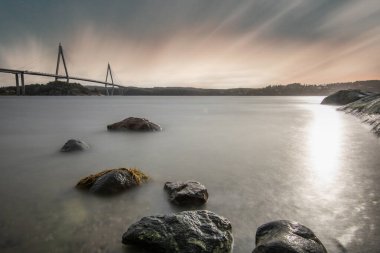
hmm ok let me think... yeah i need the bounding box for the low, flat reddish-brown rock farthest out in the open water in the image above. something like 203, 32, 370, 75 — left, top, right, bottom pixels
107, 117, 161, 132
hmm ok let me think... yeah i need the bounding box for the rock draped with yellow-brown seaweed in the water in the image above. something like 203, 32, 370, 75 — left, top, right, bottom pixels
76, 168, 148, 195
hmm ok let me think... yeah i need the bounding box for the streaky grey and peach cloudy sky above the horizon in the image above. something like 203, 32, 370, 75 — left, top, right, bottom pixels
0, 0, 380, 88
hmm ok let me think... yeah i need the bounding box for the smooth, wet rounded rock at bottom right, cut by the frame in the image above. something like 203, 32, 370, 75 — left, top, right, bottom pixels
252, 220, 327, 253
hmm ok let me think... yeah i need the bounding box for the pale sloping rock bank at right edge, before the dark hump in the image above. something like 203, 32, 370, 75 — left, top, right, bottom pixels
338, 94, 380, 136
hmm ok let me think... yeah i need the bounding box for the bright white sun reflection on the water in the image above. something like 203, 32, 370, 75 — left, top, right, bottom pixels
308, 106, 342, 188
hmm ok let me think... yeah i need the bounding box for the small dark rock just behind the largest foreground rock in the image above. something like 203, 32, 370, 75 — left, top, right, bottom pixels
164, 181, 208, 205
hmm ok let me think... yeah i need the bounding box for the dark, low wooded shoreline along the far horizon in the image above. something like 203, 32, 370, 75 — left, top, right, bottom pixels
0, 80, 380, 96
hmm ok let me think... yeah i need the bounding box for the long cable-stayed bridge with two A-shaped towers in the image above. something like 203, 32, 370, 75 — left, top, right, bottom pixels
0, 44, 126, 95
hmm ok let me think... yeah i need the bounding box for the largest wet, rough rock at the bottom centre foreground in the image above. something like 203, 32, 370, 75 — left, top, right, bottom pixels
122, 210, 233, 253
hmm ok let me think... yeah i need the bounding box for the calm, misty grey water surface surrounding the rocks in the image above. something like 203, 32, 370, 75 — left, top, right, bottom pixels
0, 97, 380, 253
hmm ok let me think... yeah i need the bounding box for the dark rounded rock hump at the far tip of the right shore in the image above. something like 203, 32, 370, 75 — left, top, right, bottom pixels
321, 90, 373, 105
